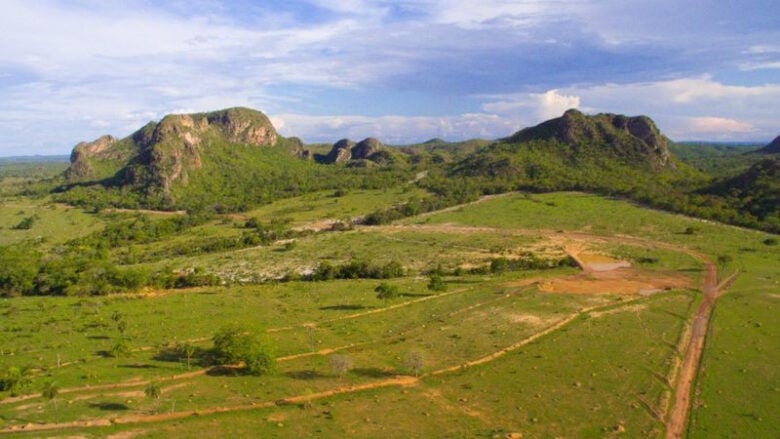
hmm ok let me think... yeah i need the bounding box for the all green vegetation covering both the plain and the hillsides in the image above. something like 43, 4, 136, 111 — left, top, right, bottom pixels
0, 112, 780, 437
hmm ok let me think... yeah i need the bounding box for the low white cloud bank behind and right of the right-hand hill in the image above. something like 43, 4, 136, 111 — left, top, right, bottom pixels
482, 76, 780, 140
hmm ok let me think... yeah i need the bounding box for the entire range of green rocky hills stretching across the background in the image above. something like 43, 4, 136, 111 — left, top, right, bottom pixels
56, 108, 780, 234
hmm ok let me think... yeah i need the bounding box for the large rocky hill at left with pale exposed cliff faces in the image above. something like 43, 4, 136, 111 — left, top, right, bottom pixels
62, 108, 310, 211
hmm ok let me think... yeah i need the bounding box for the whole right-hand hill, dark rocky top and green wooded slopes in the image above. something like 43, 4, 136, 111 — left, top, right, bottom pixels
450, 110, 701, 194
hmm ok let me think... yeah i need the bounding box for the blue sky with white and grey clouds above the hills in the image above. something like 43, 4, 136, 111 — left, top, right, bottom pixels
0, 0, 780, 156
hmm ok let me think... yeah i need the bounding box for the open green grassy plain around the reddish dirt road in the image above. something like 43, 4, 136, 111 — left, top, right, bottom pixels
0, 192, 780, 437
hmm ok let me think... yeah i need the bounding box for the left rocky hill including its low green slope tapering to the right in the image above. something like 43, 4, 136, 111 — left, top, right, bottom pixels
58, 108, 414, 211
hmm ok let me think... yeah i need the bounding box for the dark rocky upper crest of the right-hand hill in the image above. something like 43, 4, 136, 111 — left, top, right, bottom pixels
507, 109, 674, 169
